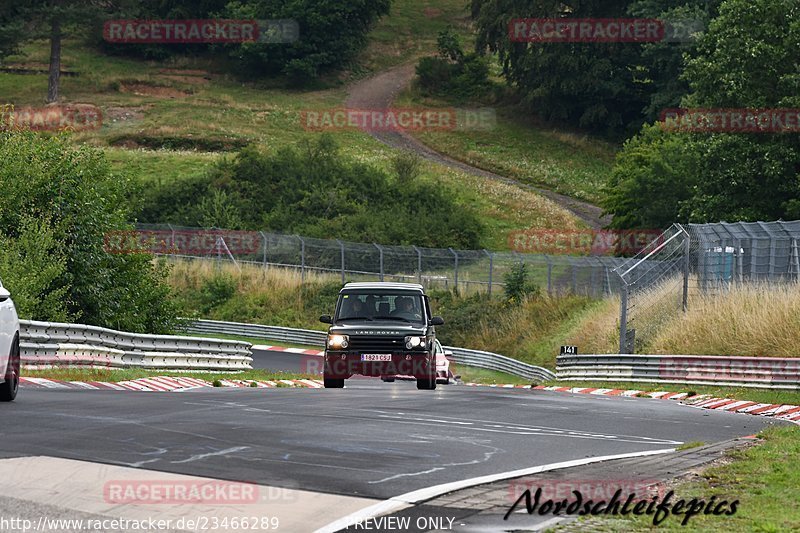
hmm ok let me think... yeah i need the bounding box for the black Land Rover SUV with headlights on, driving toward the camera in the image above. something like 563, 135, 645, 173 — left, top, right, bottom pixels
319, 282, 444, 390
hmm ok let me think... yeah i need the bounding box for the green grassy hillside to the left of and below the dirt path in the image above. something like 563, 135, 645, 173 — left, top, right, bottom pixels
0, 39, 581, 249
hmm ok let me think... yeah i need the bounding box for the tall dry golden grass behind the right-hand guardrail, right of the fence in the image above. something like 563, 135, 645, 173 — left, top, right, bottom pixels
648, 284, 800, 357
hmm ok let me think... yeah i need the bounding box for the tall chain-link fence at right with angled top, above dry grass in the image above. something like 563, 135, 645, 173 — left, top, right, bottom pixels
615, 221, 800, 353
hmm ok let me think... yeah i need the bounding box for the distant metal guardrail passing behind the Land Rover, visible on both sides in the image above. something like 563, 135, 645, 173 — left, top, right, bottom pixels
186, 320, 556, 383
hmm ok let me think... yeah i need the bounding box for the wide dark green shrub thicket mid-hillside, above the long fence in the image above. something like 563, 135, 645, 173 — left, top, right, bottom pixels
140, 135, 483, 249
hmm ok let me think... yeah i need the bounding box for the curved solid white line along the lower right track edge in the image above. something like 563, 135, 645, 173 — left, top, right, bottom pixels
315, 448, 675, 533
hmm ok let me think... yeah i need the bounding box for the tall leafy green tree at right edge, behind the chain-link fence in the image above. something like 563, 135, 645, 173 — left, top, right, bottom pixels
604, 0, 800, 227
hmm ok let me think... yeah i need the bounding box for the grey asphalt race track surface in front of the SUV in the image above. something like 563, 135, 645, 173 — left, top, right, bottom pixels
0, 378, 770, 529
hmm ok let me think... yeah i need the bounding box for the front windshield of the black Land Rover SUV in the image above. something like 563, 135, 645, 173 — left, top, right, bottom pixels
336, 290, 425, 323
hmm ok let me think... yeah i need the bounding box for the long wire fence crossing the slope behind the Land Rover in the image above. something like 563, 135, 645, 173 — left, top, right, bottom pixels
131, 224, 625, 298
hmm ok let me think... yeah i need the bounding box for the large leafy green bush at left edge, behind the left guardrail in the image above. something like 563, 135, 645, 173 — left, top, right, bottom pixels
0, 132, 177, 333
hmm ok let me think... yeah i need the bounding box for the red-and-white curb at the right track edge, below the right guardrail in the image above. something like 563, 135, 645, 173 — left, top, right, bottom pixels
532, 385, 800, 424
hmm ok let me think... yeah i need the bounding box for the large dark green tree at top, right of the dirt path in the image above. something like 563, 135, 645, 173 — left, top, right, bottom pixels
472, 0, 719, 135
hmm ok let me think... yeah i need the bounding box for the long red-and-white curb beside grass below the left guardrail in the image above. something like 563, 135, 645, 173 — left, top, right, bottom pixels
19, 377, 323, 392
